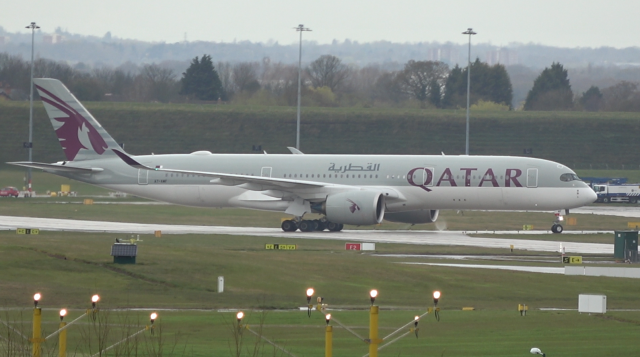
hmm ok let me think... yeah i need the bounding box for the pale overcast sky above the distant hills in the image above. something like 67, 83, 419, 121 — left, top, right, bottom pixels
5, 0, 640, 48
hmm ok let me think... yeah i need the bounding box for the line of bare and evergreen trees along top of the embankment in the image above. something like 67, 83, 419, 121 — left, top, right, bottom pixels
0, 53, 640, 111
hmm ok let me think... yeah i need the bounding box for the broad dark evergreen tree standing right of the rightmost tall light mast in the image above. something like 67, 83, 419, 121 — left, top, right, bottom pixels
524, 62, 573, 110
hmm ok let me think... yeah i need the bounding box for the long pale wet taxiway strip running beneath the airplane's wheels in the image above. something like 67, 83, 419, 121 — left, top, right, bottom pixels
0, 216, 613, 255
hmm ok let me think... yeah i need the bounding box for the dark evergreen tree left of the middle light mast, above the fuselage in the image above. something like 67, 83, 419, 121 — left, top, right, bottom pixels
180, 55, 226, 100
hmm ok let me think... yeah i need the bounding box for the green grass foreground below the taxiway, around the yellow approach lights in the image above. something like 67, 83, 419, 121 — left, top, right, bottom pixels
0, 232, 640, 356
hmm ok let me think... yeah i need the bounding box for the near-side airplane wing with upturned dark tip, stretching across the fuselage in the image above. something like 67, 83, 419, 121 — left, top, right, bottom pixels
112, 149, 404, 199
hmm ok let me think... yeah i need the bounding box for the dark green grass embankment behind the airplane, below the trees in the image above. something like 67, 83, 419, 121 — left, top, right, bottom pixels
0, 102, 640, 169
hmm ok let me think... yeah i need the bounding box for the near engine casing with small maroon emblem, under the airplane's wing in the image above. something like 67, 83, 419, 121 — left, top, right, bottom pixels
320, 191, 385, 226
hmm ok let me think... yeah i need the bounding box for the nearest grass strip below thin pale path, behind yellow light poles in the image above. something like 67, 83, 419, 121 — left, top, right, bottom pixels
6, 309, 640, 357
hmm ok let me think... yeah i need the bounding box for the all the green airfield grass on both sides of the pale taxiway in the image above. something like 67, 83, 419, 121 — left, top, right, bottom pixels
0, 164, 640, 357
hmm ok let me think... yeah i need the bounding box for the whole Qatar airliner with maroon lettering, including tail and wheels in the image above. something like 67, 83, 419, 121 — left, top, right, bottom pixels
10, 79, 596, 233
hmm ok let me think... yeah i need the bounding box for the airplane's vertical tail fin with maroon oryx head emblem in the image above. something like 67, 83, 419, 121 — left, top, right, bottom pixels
33, 78, 122, 161
